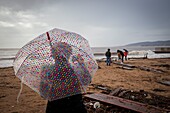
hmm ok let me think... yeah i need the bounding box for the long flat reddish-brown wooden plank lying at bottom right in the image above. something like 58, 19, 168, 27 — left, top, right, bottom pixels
84, 93, 168, 113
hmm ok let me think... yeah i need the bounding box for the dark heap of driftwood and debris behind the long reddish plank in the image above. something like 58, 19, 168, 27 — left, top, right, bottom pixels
87, 84, 170, 109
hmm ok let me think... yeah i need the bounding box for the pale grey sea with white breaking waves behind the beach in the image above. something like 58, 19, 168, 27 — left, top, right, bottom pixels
0, 46, 170, 68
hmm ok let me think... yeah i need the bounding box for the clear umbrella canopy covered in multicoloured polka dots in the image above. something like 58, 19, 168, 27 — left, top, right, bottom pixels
14, 28, 98, 101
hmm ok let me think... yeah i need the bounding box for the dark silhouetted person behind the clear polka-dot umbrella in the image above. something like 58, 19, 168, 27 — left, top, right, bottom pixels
42, 42, 88, 113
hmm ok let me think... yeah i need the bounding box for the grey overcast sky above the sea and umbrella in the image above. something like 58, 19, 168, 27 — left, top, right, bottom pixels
0, 0, 170, 48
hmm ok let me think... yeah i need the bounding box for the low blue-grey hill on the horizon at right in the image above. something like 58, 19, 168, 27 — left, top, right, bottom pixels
126, 40, 170, 46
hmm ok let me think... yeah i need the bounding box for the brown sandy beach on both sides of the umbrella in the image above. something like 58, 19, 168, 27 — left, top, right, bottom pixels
0, 58, 170, 113
